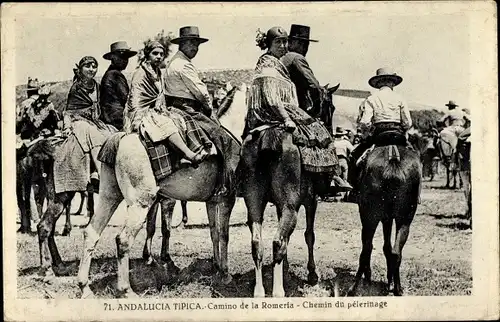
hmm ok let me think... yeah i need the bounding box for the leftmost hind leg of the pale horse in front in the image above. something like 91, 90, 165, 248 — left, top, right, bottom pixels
78, 164, 123, 298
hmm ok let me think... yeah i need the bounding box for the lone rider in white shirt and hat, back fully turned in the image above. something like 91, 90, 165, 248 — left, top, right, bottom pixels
351, 68, 412, 197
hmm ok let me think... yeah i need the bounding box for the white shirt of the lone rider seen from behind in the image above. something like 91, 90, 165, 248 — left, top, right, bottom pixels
358, 86, 412, 129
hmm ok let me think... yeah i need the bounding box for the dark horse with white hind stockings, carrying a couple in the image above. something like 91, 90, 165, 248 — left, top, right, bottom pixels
240, 86, 338, 297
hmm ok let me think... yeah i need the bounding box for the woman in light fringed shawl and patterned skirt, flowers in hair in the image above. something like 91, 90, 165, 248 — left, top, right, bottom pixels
244, 27, 344, 179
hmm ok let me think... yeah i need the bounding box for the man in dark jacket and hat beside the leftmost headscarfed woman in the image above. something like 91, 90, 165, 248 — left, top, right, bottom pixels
100, 41, 137, 131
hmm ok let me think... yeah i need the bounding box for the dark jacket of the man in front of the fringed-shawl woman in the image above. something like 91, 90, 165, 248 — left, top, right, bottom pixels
281, 52, 321, 117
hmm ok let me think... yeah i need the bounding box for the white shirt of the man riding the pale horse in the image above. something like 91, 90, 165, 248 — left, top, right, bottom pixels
165, 51, 212, 109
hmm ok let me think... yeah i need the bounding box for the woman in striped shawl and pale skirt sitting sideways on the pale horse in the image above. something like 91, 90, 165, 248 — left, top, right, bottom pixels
124, 41, 212, 163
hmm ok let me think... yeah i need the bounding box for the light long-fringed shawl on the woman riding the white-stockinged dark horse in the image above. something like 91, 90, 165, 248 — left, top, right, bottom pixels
247, 53, 298, 130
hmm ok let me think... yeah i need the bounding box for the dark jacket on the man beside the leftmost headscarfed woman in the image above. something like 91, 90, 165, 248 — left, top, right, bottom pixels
100, 65, 130, 130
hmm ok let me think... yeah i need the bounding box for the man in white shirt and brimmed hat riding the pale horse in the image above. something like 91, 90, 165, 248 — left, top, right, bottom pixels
165, 26, 240, 196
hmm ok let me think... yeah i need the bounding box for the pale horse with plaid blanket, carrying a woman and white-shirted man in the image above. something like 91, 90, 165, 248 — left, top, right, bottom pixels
78, 88, 246, 298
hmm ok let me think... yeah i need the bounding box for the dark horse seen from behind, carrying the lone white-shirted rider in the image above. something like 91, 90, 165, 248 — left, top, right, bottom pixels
348, 132, 422, 295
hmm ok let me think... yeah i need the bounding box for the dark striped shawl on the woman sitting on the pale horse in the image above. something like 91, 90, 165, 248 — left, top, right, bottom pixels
123, 62, 166, 133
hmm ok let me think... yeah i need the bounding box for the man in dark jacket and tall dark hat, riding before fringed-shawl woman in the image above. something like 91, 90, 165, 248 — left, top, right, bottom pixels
280, 24, 352, 189
